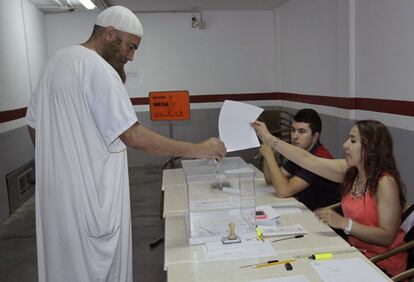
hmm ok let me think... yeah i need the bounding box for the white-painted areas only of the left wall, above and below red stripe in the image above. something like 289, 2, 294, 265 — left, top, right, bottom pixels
0, 0, 47, 133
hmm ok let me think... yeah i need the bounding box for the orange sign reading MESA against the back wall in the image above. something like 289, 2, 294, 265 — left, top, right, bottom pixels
149, 90, 190, 121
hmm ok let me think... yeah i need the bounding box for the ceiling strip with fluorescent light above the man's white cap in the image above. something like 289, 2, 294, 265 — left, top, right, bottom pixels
29, 0, 288, 13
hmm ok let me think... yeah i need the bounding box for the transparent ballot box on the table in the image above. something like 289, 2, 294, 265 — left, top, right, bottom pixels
182, 157, 256, 244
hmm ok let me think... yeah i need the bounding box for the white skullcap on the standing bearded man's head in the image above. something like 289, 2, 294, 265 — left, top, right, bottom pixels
95, 6, 144, 37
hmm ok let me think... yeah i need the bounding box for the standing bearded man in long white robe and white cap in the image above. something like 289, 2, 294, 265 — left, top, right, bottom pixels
26, 6, 225, 282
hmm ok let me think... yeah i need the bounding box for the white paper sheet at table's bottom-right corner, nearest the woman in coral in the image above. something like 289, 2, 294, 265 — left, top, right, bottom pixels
312, 258, 388, 282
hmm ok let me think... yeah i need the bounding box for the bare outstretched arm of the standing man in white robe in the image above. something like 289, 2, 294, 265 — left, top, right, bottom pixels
120, 123, 226, 160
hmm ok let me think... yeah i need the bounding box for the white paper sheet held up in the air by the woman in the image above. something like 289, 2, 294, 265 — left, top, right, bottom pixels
219, 100, 263, 152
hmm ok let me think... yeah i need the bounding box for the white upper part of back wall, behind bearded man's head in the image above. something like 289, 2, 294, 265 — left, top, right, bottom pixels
46, 11, 275, 97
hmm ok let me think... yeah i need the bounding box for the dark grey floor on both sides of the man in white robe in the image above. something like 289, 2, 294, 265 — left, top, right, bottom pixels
0, 166, 166, 282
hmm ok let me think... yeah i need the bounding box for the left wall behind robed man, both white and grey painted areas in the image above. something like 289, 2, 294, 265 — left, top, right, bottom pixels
0, 0, 47, 221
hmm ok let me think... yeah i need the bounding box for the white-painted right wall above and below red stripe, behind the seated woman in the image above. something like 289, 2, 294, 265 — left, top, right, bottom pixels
275, 0, 414, 125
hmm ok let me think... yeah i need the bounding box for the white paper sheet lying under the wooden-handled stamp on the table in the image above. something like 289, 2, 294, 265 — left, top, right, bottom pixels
204, 239, 276, 261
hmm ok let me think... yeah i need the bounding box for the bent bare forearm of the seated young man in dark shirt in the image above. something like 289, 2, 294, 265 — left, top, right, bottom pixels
260, 144, 309, 198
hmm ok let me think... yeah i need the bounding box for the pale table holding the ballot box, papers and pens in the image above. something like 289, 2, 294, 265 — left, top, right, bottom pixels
162, 166, 391, 282
